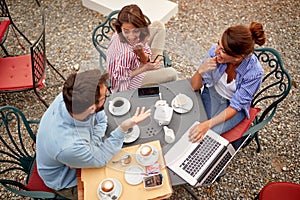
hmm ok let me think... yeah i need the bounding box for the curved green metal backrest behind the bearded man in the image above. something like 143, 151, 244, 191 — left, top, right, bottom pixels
0, 106, 38, 186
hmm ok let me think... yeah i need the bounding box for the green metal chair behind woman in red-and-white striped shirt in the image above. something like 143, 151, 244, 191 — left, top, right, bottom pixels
92, 10, 172, 71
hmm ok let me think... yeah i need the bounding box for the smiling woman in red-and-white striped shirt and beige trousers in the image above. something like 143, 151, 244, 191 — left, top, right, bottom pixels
106, 5, 177, 92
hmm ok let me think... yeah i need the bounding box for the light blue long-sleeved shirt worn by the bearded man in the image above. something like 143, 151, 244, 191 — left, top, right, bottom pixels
36, 94, 124, 190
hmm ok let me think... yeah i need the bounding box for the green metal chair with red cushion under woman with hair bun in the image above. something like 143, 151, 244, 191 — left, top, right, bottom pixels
182, 48, 292, 199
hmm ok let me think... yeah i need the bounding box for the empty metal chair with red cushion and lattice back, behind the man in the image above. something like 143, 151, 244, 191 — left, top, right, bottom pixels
0, 11, 48, 107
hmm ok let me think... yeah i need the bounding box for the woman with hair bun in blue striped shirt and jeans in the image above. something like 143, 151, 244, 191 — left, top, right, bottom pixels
190, 22, 266, 142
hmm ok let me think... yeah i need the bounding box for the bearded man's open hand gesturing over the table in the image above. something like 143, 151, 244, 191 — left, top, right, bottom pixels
120, 107, 151, 131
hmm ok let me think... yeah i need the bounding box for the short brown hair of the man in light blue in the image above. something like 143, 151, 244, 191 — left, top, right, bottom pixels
63, 69, 108, 114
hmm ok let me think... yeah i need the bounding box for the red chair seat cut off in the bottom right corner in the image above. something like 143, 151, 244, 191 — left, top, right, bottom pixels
255, 182, 300, 200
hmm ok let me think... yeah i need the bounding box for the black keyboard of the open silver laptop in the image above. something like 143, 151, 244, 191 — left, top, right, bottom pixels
180, 135, 221, 177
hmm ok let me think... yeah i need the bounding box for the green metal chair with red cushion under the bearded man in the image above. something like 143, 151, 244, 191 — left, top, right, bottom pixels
0, 106, 65, 199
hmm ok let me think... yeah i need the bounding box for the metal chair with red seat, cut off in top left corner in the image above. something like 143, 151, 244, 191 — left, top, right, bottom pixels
0, 0, 66, 81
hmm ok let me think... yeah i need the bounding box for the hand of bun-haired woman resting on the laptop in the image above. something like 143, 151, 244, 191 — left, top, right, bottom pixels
189, 120, 210, 142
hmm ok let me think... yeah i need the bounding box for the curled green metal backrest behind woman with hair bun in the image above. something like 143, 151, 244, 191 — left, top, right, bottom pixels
244, 48, 292, 148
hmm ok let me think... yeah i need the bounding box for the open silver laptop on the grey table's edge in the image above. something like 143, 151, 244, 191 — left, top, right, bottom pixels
164, 122, 248, 186
